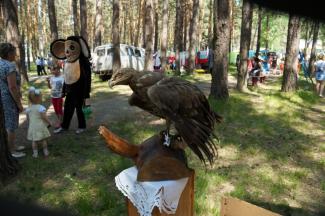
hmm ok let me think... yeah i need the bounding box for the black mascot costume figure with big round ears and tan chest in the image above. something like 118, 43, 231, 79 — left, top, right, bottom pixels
50, 36, 91, 133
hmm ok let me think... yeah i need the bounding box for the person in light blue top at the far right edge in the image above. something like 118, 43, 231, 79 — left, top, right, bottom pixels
315, 53, 325, 97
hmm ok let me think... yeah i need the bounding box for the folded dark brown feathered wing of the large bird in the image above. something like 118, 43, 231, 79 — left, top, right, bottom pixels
147, 77, 221, 163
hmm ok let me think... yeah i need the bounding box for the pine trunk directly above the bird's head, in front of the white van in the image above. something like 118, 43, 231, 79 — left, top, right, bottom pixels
112, 0, 121, 73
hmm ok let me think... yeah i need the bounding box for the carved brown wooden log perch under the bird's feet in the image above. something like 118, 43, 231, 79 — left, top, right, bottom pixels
98, 126, 191, 181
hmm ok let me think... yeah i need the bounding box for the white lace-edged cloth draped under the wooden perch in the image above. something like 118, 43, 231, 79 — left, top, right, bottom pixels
115, 166, 188, 216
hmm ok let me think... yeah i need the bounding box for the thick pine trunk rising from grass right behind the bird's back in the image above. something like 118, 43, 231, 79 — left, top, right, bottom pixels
210, 0, 231, 99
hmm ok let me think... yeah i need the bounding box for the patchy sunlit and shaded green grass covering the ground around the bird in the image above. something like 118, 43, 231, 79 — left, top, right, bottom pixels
0, 66, 325, 216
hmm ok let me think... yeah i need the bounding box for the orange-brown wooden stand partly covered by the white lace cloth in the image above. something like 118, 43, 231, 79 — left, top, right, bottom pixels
126, 170, 195, 216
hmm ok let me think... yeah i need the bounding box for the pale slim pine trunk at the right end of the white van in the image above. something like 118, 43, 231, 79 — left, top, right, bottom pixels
144, 0, 153, 71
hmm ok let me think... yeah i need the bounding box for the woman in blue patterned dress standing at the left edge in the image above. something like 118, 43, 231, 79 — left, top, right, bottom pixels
0, 43, 26, 158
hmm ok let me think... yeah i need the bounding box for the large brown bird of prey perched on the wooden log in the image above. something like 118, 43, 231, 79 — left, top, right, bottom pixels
110, 68, 222, 163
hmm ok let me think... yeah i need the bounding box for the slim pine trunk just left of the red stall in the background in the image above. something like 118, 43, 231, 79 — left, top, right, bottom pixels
188, 0, 200, 73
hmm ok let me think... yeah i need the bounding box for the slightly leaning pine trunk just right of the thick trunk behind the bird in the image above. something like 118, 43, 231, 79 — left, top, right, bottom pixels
236, 0, 253, 91
